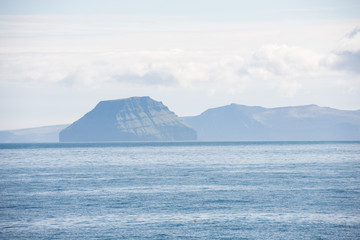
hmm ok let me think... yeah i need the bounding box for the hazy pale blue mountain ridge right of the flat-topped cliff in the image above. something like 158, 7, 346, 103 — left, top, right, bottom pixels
183, 104, 360, 141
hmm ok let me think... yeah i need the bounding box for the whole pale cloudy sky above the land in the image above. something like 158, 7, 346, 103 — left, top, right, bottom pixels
0, 0, 360, 130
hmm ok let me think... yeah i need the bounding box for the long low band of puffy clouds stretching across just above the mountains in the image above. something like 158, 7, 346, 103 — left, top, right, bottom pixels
0, 40, 360, 97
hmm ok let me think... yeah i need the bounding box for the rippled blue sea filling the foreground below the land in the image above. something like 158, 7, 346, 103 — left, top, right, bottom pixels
0, 142, 360, 239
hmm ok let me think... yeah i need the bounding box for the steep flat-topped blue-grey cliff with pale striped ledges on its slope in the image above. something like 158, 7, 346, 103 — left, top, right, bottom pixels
59, 97, 196, 142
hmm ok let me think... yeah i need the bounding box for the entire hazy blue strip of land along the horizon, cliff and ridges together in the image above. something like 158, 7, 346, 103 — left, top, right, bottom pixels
0, 97, 360, 143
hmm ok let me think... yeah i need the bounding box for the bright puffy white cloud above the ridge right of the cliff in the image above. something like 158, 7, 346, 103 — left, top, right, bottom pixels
233, 45, 327, 98
